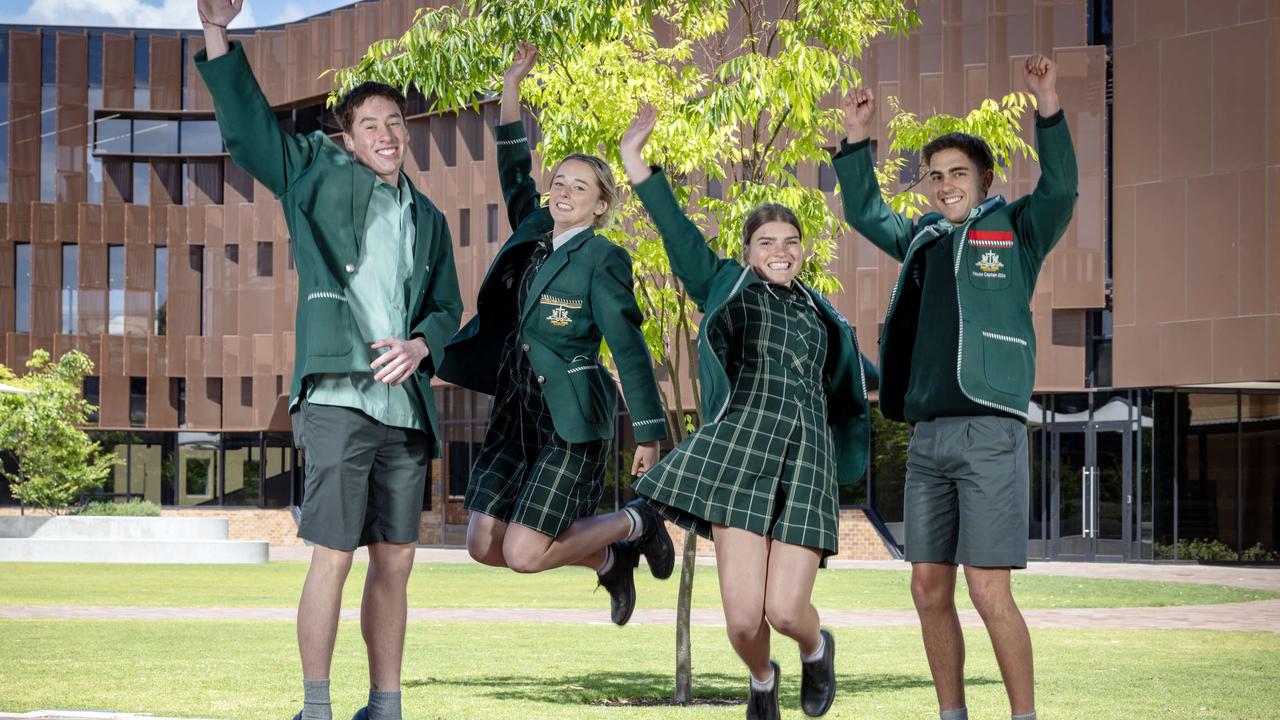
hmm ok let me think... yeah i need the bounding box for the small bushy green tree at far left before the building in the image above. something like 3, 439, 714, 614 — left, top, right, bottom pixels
0, 350, 116, 512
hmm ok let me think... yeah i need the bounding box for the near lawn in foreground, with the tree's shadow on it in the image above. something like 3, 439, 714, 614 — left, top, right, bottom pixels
0, 620, 1280, 720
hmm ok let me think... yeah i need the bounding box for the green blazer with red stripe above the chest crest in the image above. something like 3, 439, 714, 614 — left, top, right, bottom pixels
832, 111, 1076, 420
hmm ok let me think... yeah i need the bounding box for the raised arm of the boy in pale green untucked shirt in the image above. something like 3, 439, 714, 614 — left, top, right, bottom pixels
196, 0, 324, 196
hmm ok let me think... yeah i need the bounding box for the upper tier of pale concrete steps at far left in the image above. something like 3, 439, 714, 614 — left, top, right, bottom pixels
0, 515, 228, 541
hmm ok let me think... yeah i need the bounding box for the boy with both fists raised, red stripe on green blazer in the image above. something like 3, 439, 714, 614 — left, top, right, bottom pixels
835, 55, 1076, 720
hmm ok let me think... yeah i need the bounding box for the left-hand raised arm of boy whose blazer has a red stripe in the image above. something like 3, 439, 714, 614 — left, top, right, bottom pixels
831, 88, 915, 261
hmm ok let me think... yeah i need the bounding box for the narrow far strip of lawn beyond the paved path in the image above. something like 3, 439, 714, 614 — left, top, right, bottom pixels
0, 562, 1280, 610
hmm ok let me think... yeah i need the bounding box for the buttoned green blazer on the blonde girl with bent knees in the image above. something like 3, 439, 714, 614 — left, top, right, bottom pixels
440, 122, 667, 442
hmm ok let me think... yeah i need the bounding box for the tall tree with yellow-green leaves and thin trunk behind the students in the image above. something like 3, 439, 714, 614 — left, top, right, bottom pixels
330, 0, 1030, 702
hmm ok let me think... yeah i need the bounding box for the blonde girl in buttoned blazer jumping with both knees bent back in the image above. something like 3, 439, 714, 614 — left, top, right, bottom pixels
440, 44, 675, 625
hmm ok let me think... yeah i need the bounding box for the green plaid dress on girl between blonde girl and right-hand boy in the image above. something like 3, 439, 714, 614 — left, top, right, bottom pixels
634, 283, 840, 555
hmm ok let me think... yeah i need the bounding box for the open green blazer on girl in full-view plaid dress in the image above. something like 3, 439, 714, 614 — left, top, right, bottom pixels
635, 170, 876, 486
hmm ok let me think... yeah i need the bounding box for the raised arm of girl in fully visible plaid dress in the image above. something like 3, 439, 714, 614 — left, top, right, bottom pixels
621, 105, 737, 307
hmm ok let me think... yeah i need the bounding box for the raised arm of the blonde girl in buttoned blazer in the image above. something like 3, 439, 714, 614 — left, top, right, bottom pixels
494, 42, 541, 229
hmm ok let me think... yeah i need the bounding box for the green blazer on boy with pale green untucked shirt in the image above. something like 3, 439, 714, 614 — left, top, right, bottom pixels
196, 42, 462, 457
